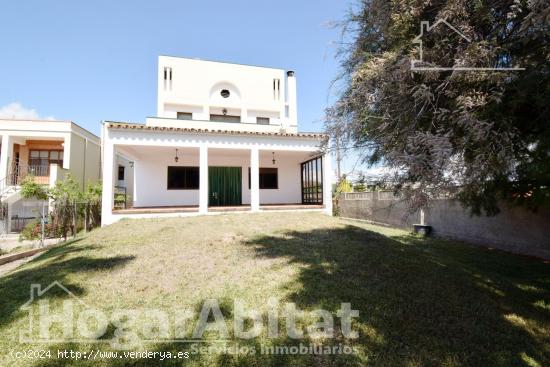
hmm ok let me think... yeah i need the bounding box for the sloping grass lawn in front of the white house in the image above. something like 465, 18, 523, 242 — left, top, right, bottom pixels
0, 213, 550, 366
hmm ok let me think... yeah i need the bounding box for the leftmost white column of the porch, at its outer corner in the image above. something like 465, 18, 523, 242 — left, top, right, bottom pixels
101, 137, 116, 226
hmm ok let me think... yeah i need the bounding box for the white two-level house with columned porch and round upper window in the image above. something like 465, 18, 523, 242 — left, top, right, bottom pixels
102, 56, 332, 225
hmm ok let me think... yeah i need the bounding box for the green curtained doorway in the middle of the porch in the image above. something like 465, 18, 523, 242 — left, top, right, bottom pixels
208, 167, 242, 206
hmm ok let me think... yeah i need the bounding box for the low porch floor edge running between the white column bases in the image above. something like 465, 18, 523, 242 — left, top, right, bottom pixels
113, 204, 324, 214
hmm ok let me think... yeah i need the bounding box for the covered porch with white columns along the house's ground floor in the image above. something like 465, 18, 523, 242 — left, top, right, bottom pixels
103, 126, 332, 224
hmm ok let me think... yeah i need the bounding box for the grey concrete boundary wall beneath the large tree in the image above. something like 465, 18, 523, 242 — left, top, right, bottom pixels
339, 192, 550, 258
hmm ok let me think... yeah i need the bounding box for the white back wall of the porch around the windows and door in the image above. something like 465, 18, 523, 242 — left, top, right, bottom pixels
134, 149, 303, 207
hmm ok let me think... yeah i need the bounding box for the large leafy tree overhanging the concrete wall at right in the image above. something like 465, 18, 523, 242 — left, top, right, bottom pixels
327, 0, 550, 214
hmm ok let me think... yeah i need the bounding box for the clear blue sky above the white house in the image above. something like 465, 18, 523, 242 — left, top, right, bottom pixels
0, 0, 370, 175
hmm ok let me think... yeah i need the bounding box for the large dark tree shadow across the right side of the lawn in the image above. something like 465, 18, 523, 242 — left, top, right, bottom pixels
243, 225, 550, 366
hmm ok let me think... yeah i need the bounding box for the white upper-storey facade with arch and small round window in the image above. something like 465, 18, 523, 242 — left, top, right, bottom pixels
153, 56, 297, 131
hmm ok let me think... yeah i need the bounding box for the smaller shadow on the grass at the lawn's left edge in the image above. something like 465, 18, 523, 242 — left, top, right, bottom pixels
0, 239, 134, 325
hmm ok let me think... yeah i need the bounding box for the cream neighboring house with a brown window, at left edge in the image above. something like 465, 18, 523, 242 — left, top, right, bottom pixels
0, 119, 101, 234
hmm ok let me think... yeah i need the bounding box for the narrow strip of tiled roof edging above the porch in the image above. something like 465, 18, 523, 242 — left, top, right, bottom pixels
105, 121, 327, 139
